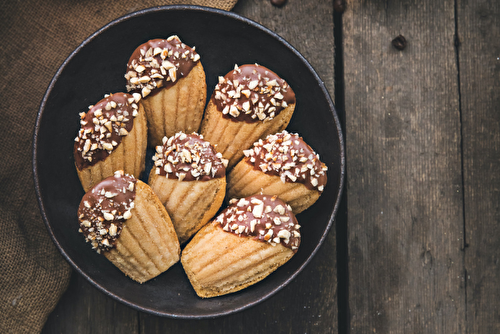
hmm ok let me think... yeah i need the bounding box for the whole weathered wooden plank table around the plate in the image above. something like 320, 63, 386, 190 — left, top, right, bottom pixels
43, 0, 500, 333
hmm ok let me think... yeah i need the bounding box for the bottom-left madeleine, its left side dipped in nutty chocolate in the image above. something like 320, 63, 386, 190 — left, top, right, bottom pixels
78, 171, 180, 283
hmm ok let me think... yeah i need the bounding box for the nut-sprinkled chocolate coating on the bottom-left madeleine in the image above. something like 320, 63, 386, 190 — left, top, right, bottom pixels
78, 171, 137, 253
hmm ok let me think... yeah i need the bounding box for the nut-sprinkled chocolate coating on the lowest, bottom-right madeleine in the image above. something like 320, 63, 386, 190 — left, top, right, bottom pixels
215, 195, 300, 252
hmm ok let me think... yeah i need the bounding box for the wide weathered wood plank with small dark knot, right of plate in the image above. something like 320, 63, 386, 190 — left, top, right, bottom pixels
343, 0, 465, 333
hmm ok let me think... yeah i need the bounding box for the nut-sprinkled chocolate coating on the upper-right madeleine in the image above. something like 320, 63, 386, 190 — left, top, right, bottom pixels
212, 64, 295, 123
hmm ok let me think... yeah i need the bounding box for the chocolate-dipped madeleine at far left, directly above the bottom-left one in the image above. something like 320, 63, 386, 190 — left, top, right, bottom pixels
73, 93, 147, 191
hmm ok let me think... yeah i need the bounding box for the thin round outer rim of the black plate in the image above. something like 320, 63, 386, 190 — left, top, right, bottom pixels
32, 5, 345, 319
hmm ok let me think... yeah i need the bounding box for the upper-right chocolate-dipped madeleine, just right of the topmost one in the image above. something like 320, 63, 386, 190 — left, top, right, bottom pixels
200, 64, 295, 170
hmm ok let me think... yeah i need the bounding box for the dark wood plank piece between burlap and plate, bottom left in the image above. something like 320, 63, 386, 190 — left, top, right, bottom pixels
42, 272, 139, 334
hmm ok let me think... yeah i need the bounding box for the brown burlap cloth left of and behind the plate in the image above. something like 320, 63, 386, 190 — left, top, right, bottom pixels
0, 0, 237, 333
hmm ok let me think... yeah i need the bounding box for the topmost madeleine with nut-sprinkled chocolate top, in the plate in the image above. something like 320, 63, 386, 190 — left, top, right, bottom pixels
125, 36, 207, 147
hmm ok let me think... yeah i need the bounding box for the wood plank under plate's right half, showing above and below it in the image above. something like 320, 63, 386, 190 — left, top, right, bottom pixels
140, 0, 337, 333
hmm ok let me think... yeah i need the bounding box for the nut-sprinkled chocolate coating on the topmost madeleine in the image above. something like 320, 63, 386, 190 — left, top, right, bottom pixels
125, 36, 200, 98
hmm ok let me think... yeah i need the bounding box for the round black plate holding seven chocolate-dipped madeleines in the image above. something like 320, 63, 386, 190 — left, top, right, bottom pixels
33, 6, 344, 318
